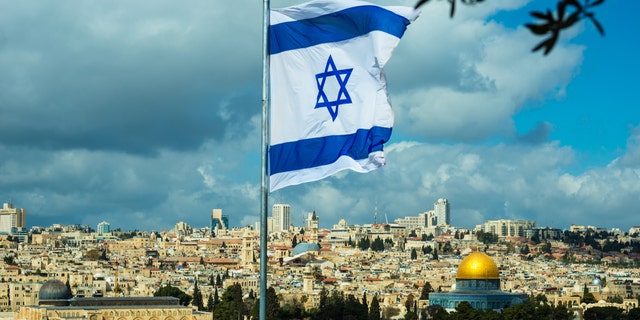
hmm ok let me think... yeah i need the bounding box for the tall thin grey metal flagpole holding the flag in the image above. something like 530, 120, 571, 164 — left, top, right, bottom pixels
260, 0, 271, 320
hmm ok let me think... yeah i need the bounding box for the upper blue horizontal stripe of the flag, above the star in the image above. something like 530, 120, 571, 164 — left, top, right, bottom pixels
269, 6, 411, 54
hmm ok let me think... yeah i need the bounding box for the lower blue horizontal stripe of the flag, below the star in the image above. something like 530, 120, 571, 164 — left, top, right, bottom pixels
269, 127, 391, 174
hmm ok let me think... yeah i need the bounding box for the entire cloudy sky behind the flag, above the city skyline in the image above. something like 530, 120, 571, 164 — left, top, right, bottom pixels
0, 0, 640, 231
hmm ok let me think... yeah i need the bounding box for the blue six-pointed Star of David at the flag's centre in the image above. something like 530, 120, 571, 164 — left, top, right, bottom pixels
315, 55, 353, 121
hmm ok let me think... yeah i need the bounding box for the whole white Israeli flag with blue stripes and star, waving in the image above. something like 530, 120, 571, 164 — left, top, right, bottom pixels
269, 0, 418, 191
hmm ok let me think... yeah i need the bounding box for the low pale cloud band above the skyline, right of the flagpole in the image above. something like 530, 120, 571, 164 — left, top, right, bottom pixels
272, 134, 640, 228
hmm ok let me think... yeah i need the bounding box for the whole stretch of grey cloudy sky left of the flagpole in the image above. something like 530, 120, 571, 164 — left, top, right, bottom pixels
0, 1, 261, 229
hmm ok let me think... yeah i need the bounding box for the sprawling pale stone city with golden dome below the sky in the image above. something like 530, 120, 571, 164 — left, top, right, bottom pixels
0, 198, 640, 320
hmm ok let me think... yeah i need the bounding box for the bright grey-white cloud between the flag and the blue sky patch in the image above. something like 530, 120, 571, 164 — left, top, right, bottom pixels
387, 2, 583, 141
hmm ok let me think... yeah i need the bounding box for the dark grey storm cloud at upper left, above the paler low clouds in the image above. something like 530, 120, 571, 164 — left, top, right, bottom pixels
0, 2, 261, 154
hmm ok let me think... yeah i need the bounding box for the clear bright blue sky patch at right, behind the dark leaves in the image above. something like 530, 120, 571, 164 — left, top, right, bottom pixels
502, 0, 640, 171
